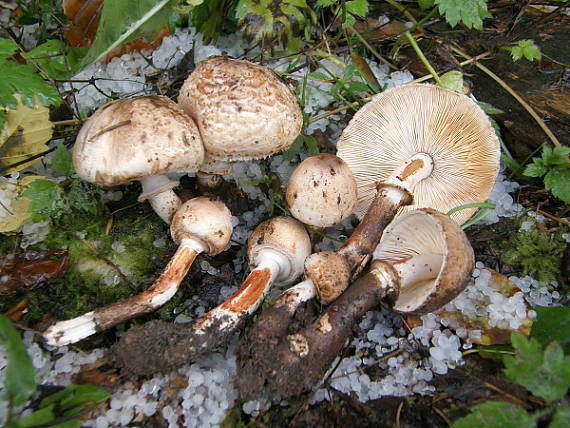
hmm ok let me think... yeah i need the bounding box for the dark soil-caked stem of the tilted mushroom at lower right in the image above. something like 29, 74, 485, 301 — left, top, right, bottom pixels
238, 262, 399, 400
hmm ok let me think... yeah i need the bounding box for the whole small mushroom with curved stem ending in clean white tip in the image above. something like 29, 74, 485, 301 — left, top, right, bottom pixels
44, 197, 232, 346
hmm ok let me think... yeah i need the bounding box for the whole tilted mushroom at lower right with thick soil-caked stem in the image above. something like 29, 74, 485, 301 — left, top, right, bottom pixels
238, 209, 474, 400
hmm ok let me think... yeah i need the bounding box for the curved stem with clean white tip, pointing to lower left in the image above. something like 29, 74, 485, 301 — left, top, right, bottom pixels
43, 238, 206, 346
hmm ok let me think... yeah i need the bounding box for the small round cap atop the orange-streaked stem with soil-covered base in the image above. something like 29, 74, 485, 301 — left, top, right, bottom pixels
247, 217, 311, 285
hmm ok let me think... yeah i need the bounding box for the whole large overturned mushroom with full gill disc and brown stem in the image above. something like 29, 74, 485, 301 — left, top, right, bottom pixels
307, 84, 500, 294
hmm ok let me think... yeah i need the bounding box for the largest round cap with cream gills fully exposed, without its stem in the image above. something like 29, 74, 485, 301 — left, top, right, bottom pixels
337, 84, 500, 224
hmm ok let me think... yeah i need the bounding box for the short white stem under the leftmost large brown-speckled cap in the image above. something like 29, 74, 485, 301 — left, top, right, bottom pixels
138, 175, 182, 224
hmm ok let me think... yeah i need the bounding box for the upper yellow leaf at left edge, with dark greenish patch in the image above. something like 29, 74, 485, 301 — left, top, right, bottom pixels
0, 101, 53, 174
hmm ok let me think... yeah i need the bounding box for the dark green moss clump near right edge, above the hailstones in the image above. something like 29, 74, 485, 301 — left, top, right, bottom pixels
501, 219, 568, 284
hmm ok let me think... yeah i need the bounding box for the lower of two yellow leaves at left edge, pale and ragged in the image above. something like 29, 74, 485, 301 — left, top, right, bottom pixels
0, 175, 45, 233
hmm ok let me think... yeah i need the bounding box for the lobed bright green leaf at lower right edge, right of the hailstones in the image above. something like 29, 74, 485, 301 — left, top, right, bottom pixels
503, 332, 570, 402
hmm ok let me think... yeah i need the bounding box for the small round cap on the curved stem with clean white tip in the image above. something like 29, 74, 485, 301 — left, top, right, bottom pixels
170, 196, 233, 256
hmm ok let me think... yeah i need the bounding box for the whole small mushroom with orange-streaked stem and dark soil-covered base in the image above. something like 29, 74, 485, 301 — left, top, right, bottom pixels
108, 217, 311, 375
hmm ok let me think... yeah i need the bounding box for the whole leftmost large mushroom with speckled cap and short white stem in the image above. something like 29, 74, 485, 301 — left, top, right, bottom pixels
73, 96, 204, 223
